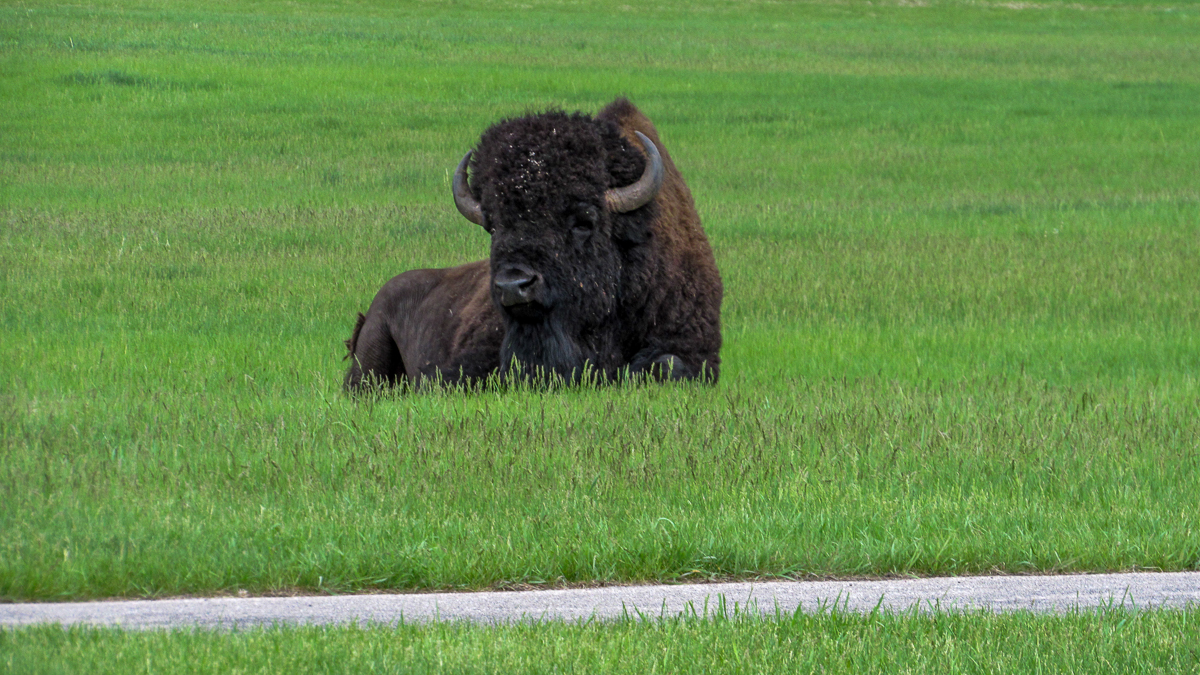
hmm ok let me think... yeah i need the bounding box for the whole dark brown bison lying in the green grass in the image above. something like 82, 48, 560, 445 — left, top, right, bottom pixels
344, 98, 724, 392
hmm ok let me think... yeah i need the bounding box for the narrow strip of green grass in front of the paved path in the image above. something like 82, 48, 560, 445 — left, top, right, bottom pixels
0, 609, 1200, 675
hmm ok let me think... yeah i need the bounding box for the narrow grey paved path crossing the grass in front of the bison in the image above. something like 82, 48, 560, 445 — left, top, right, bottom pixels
0, 572, 1200, 628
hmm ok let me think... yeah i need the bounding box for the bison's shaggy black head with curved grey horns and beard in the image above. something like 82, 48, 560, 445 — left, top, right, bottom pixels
454, 113, 662, 380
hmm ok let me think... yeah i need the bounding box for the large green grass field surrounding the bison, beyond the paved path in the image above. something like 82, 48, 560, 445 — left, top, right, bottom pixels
0, 2, 1200, 598
